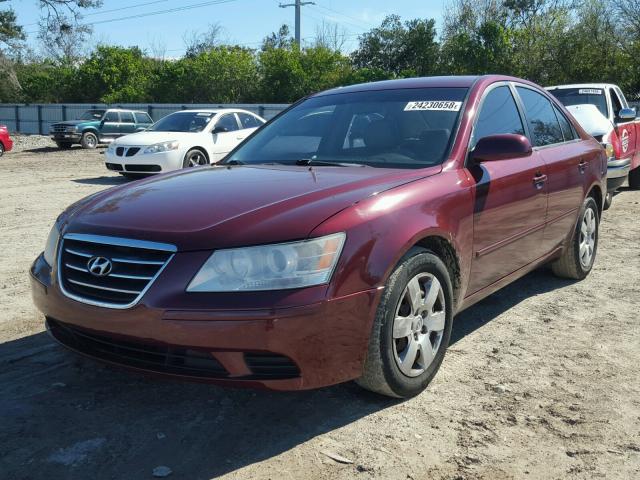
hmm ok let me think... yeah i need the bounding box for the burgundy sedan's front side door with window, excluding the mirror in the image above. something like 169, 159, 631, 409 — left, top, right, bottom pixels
467, 82, 547, 294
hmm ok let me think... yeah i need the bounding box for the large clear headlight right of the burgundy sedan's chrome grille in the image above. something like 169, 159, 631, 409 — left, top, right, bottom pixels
187, 233, 346, 292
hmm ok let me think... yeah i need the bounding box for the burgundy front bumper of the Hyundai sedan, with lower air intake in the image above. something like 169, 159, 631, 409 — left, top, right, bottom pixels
31, 256, 381, 390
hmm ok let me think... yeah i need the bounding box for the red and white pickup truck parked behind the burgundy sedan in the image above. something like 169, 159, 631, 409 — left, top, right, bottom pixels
547, 83, 640, 208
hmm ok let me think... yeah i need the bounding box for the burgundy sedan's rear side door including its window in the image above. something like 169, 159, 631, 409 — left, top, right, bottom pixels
516, 85, 592, 251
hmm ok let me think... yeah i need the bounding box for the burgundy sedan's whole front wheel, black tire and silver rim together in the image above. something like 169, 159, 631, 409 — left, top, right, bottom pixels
356, 249, 453, 398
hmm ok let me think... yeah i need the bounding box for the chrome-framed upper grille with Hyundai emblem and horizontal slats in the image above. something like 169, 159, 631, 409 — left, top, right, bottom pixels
58, 234, 175, 308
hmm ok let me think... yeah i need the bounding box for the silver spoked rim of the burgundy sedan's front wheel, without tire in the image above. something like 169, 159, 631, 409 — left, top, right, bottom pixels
393, 273, 447, 377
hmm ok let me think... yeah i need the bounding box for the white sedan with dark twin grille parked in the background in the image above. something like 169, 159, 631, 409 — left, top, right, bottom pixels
105, 109, 265, 176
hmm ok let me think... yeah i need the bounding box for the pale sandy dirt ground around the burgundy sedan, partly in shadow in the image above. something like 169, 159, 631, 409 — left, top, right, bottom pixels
0, 138, 640, 480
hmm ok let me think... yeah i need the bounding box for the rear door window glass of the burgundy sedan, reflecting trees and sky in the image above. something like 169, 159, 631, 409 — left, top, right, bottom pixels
516, 87, 564, 147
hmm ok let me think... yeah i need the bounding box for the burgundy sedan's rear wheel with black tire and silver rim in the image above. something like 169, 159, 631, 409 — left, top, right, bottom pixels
551, 197, 600, 280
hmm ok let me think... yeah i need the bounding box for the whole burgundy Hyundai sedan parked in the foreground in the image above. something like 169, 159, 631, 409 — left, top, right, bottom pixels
31, 76, 607, 397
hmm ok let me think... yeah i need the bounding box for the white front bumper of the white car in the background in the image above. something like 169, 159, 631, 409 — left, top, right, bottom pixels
105, 147, 183, 174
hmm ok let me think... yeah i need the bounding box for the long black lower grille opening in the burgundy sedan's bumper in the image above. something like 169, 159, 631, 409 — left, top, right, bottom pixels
47, 318, 228, 378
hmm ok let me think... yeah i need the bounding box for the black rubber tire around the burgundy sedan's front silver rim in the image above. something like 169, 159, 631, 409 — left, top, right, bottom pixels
356, 249, 453, 398
